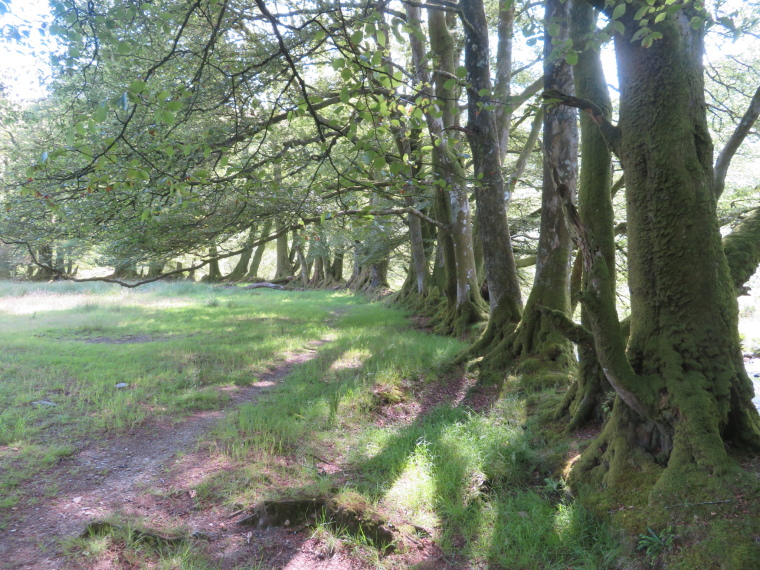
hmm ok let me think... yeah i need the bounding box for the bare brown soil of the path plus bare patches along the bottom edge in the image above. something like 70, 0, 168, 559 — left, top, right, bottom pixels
0, 332, 460, 570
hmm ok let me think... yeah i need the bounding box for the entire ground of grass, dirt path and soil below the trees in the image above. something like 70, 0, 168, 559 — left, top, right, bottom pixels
0, 284, 760, 570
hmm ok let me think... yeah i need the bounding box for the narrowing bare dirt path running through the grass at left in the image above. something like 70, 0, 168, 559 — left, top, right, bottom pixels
0, 338, 331, 570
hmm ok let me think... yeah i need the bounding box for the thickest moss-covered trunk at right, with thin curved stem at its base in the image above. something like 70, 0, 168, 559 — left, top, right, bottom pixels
560, 2, 760, 506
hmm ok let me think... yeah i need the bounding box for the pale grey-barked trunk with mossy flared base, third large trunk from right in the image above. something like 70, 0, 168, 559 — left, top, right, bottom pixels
468, 0, 578, 385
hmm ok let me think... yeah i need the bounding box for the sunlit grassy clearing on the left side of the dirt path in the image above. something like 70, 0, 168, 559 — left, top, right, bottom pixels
0, 283, 340, 506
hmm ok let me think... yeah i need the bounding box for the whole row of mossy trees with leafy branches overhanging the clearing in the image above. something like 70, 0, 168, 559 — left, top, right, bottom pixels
0, 0, 760, 520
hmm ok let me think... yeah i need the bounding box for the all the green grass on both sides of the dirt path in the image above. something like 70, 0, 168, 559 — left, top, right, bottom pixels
0, 283, 622, 569
